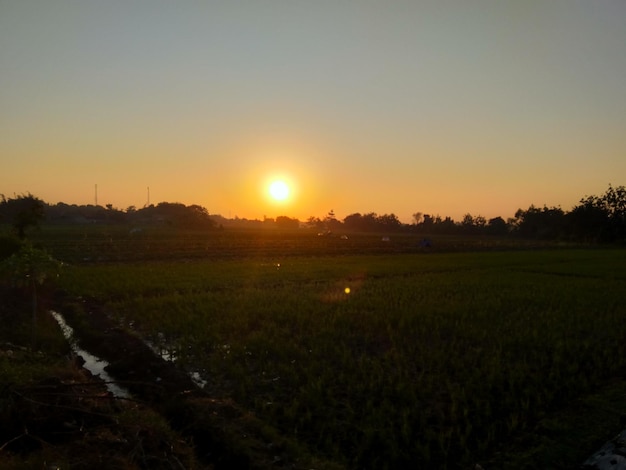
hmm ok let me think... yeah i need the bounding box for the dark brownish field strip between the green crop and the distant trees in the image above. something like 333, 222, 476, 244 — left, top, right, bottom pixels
29, 225, 556, 264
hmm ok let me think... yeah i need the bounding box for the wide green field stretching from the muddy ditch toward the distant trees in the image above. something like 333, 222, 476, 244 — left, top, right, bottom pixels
1, 223, 626, 468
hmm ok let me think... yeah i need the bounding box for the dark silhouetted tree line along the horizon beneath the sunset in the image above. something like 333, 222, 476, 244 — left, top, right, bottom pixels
0, 185, 626, 243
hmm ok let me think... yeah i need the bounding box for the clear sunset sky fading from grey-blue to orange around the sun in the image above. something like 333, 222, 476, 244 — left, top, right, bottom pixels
0, 0, 626, 222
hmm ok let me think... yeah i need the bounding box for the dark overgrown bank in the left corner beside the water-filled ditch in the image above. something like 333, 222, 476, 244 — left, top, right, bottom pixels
0, 280, 199, 470
